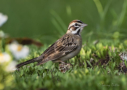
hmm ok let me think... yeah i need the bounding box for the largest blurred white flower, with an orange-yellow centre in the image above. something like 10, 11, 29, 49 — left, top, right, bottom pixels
9, 42, 29, 59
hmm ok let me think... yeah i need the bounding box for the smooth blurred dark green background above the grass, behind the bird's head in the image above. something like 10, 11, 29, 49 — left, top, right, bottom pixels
0, 0, 127, 44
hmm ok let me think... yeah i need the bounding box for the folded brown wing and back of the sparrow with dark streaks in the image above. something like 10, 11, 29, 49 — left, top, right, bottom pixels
39, 34, 78, 64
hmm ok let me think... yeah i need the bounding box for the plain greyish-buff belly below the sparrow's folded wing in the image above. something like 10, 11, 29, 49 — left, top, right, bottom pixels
60, 47, 81, 61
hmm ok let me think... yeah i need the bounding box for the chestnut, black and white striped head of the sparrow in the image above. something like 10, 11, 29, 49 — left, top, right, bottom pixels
67, 20, 87, 35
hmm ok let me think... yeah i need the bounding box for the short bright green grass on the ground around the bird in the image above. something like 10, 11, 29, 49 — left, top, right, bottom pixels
9, 40, 127, 90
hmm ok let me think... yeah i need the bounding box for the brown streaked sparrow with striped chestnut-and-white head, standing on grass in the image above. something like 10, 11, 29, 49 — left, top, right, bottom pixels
16, 20, 87, 72
